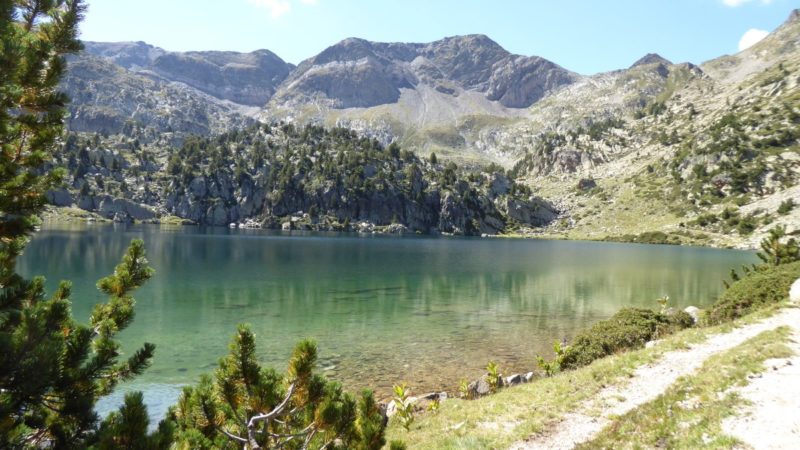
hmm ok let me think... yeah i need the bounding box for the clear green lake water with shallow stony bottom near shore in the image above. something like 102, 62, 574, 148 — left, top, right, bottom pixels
19, 225, 756, 420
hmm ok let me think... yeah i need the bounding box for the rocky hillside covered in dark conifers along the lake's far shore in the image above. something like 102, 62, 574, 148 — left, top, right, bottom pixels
51, 124, 557, 234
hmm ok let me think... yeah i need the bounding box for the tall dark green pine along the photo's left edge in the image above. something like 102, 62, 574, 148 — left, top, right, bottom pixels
0, 0, 170, 448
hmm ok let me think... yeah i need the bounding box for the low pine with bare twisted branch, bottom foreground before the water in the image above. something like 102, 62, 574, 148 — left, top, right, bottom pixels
170, 325, 386, 450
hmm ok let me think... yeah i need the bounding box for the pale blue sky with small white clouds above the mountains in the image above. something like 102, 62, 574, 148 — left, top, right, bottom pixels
81, 0, 800, 74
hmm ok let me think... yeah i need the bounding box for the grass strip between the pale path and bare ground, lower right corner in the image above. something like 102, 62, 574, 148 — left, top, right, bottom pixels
577, 327, 791, 449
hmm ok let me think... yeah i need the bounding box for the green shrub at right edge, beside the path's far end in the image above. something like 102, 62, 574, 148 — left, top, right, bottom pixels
708, 262, 800, 324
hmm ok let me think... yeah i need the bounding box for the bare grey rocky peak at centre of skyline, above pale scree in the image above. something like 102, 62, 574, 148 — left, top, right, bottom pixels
273, 34, 576, 109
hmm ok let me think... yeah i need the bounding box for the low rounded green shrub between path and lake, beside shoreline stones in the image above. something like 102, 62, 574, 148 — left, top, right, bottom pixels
561, 308, 693, 369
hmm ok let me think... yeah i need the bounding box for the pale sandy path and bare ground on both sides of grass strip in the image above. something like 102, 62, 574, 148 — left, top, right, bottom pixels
511, 308, 800, 449
